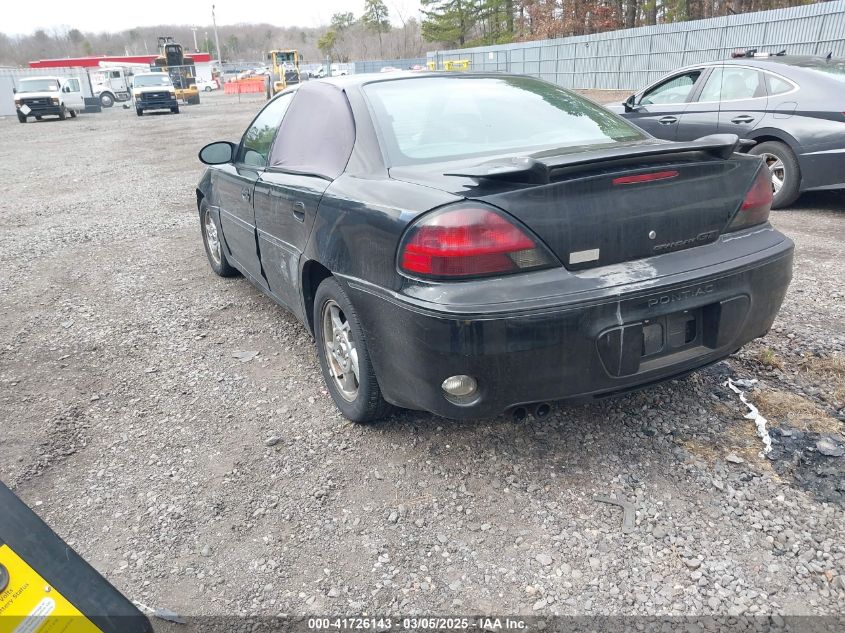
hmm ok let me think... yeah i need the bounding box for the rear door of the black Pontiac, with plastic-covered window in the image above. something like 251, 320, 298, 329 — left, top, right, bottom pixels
255, 82, 355, 312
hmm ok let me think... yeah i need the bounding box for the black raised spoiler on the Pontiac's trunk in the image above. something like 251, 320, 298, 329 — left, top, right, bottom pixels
444, 134, 754, 184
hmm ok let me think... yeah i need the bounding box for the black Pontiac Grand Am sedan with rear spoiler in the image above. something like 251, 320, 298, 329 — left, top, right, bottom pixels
196, 73, 793, 422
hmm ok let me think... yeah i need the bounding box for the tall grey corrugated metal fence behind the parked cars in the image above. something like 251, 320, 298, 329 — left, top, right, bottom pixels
426, 0, 845, 90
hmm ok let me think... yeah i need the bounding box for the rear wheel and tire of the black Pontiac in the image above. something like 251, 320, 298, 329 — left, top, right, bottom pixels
314, 277, 393, 423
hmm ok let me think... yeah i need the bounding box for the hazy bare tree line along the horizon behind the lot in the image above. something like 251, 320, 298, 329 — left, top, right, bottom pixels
0, 0, 813, 66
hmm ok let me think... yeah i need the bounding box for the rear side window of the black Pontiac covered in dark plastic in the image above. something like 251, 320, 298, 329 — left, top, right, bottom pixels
270, 81, 355, 180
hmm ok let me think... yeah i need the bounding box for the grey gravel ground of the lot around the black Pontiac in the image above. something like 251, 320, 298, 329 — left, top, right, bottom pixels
0, 90, 845, 615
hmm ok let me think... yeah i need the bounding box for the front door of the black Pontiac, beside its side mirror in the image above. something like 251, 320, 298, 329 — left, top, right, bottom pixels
213, 95, 284, 288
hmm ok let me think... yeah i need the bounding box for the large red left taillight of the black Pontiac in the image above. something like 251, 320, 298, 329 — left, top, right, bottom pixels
399, 207, 555, 278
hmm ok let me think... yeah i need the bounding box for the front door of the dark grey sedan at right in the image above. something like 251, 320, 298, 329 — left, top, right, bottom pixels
623, 68, 702, 141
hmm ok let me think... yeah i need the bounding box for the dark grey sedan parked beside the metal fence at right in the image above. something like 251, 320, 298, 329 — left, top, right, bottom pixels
607, 53, 845, 208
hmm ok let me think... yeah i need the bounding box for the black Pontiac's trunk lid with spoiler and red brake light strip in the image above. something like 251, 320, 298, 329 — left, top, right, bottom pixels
391, 135, 759, 270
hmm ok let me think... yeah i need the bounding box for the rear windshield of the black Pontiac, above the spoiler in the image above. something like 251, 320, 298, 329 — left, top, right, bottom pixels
364, 75, 645, 166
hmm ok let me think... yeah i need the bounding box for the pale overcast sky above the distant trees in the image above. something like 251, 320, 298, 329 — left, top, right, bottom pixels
0, 0, 420, 35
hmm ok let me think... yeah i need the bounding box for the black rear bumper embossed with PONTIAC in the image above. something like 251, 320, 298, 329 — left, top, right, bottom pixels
346, 230, 793, 419
